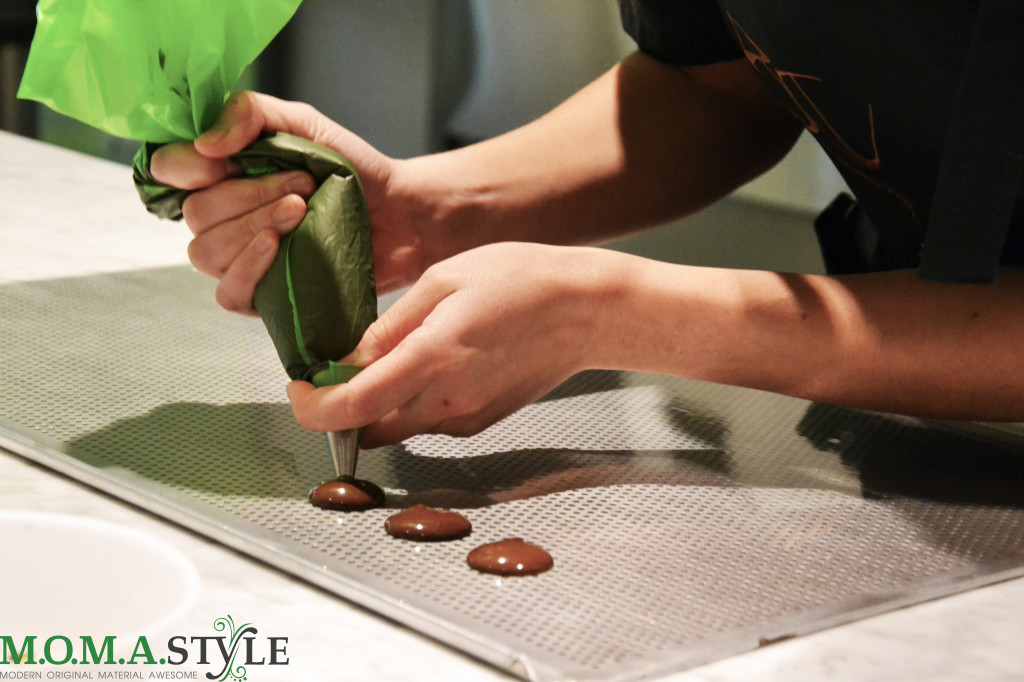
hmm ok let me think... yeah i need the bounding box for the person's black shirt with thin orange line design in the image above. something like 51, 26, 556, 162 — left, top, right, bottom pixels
620, 0, 1024, 276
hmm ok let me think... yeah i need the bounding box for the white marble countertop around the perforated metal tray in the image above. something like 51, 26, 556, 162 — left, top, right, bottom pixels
0, 133, 1024, 682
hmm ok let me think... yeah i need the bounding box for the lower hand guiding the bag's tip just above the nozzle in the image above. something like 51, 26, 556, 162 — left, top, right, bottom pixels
289, 244, 621, 447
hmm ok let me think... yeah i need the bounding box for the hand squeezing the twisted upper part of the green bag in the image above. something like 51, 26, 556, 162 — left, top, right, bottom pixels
151, 92, 424, 314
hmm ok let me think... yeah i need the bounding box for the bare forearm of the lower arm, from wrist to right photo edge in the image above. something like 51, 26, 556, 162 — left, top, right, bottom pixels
596, 259, 1024, 421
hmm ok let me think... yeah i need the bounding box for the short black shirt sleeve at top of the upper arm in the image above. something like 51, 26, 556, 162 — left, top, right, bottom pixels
618, 0, 742, 67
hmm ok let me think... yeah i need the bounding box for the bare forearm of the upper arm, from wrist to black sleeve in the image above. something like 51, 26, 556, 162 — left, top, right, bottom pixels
394, 54, 800, 265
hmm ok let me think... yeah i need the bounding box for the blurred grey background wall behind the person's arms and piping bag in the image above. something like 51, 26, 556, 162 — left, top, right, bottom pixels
0, 0, 845, 271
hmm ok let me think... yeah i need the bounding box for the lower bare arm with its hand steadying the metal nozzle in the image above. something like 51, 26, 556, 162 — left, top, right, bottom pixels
290, 244, 1024, 447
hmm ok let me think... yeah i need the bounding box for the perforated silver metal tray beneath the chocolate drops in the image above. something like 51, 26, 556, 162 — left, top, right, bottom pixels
0, 267, 1024, 680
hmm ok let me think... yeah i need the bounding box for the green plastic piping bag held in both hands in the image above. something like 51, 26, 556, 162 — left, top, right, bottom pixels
18, 0, 377, 386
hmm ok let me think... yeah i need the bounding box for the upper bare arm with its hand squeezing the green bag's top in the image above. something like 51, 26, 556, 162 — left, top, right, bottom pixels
153, 54, 800, 303
